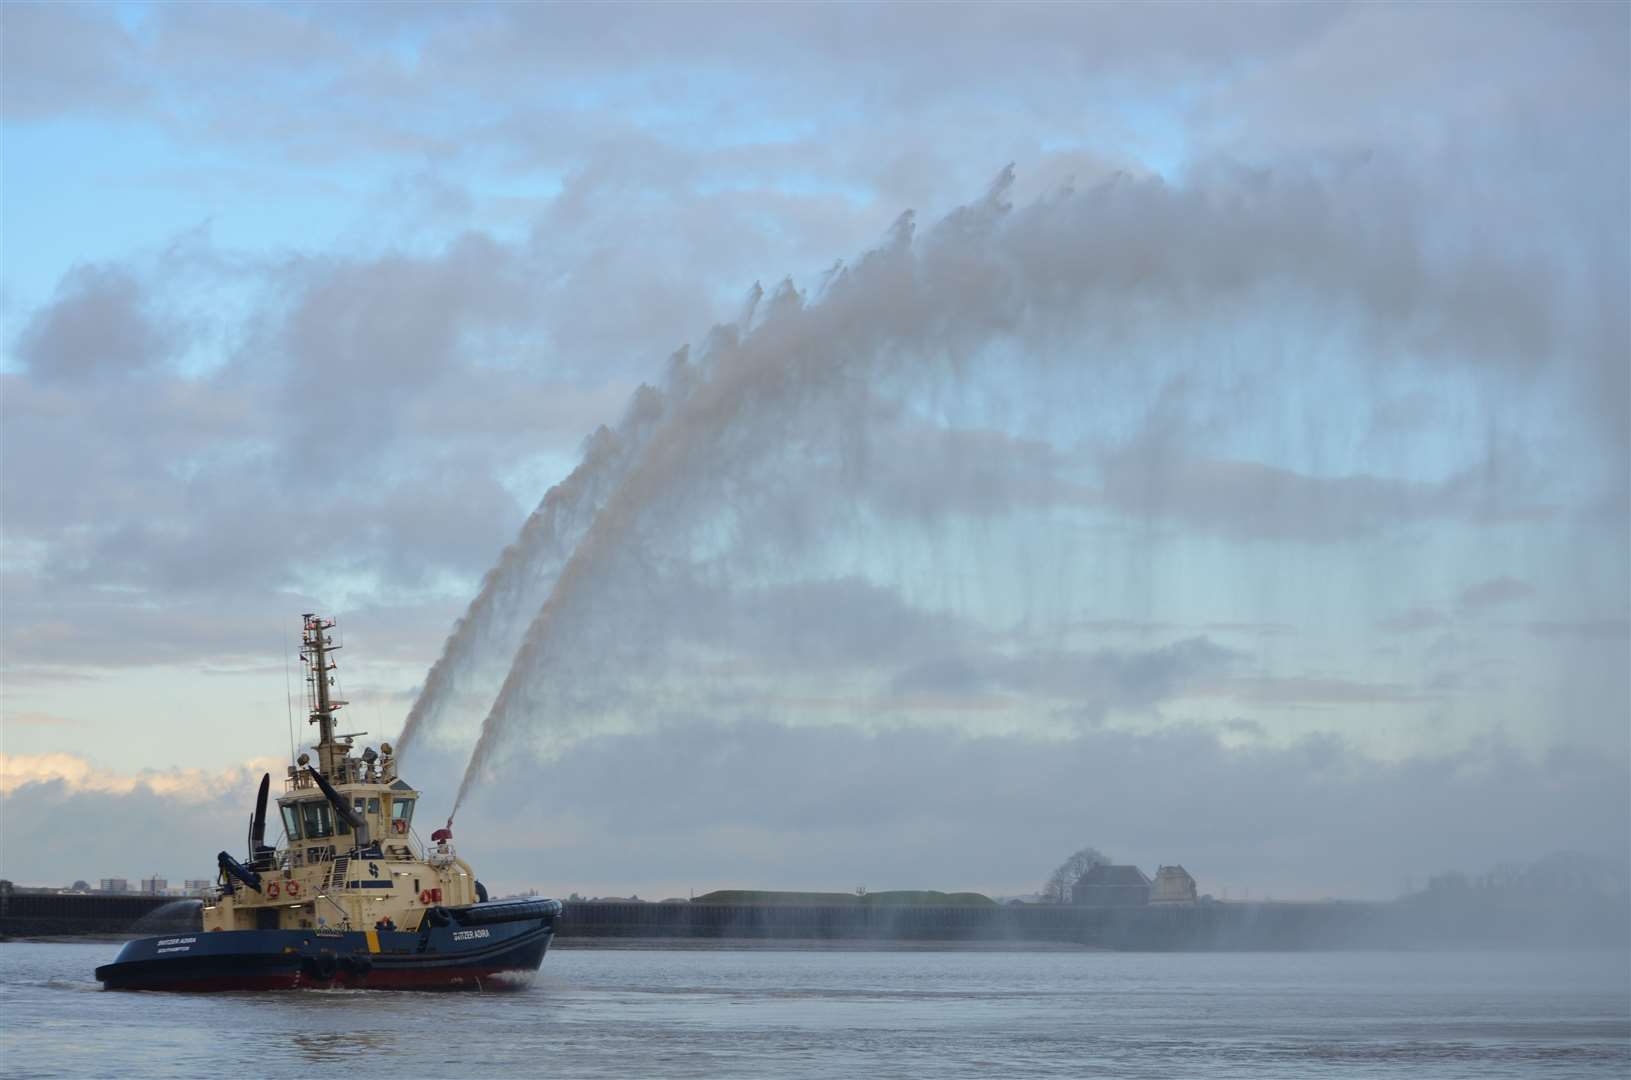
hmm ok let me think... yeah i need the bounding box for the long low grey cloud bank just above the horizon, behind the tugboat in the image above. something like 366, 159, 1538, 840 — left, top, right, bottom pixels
0, 721, 1631, 897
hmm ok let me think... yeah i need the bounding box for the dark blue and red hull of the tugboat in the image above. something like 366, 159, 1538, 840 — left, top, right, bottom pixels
96, 901, 561, 992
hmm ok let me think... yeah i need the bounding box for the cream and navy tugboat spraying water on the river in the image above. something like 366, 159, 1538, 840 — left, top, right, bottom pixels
96, 615, 561, 990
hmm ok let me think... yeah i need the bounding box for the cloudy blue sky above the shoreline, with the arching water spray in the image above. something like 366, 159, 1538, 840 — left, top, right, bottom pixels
0, 3, 1631, 899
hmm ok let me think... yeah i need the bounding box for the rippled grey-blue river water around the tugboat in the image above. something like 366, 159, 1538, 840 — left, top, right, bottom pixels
0, 943, 1631, 1080
